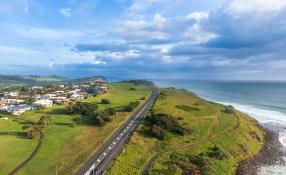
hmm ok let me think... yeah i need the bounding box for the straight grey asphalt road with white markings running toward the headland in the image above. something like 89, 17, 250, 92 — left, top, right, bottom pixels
76, 88, 157, 175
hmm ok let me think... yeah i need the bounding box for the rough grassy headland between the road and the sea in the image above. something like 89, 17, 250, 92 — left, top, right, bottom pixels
107, 89, 264, 175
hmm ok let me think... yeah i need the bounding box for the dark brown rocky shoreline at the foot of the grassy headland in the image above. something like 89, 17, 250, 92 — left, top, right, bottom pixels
235, 124, 286, 175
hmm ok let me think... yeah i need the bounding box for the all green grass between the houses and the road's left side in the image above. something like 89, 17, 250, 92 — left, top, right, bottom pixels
0, 83, 151, 175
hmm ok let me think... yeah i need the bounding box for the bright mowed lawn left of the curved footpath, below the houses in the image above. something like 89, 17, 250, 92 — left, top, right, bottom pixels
0, 117, 37, 174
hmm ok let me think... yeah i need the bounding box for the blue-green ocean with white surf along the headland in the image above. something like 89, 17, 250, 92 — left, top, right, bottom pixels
153, 80, 286, 175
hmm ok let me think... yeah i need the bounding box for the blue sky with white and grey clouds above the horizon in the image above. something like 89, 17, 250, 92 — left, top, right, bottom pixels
0, 0, 286, 80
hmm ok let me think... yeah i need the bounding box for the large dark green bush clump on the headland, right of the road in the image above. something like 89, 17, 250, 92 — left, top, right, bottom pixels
144, 113, 191, 139
